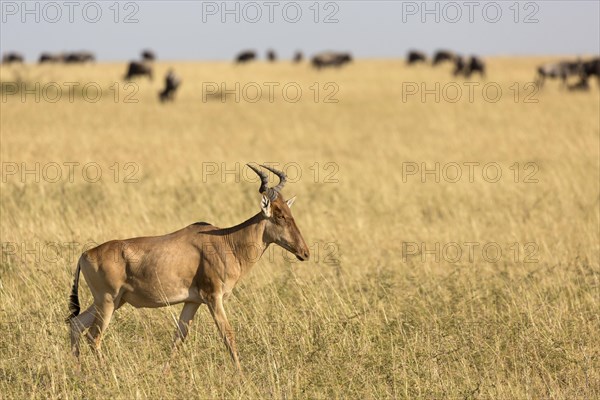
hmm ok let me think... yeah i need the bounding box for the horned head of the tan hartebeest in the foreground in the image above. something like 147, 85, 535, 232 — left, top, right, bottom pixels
248, 164, 310, 261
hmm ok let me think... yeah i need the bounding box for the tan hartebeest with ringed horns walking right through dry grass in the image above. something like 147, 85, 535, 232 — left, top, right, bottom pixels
67, 165, 309, 371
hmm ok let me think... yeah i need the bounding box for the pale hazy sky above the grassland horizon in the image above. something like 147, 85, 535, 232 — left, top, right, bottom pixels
0, 0, 600, 62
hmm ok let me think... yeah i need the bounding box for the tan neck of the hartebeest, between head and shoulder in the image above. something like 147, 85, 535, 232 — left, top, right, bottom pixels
223, 213, 270, 275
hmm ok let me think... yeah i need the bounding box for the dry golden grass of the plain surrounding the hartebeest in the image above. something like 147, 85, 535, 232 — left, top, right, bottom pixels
0, 58, 600, 399
